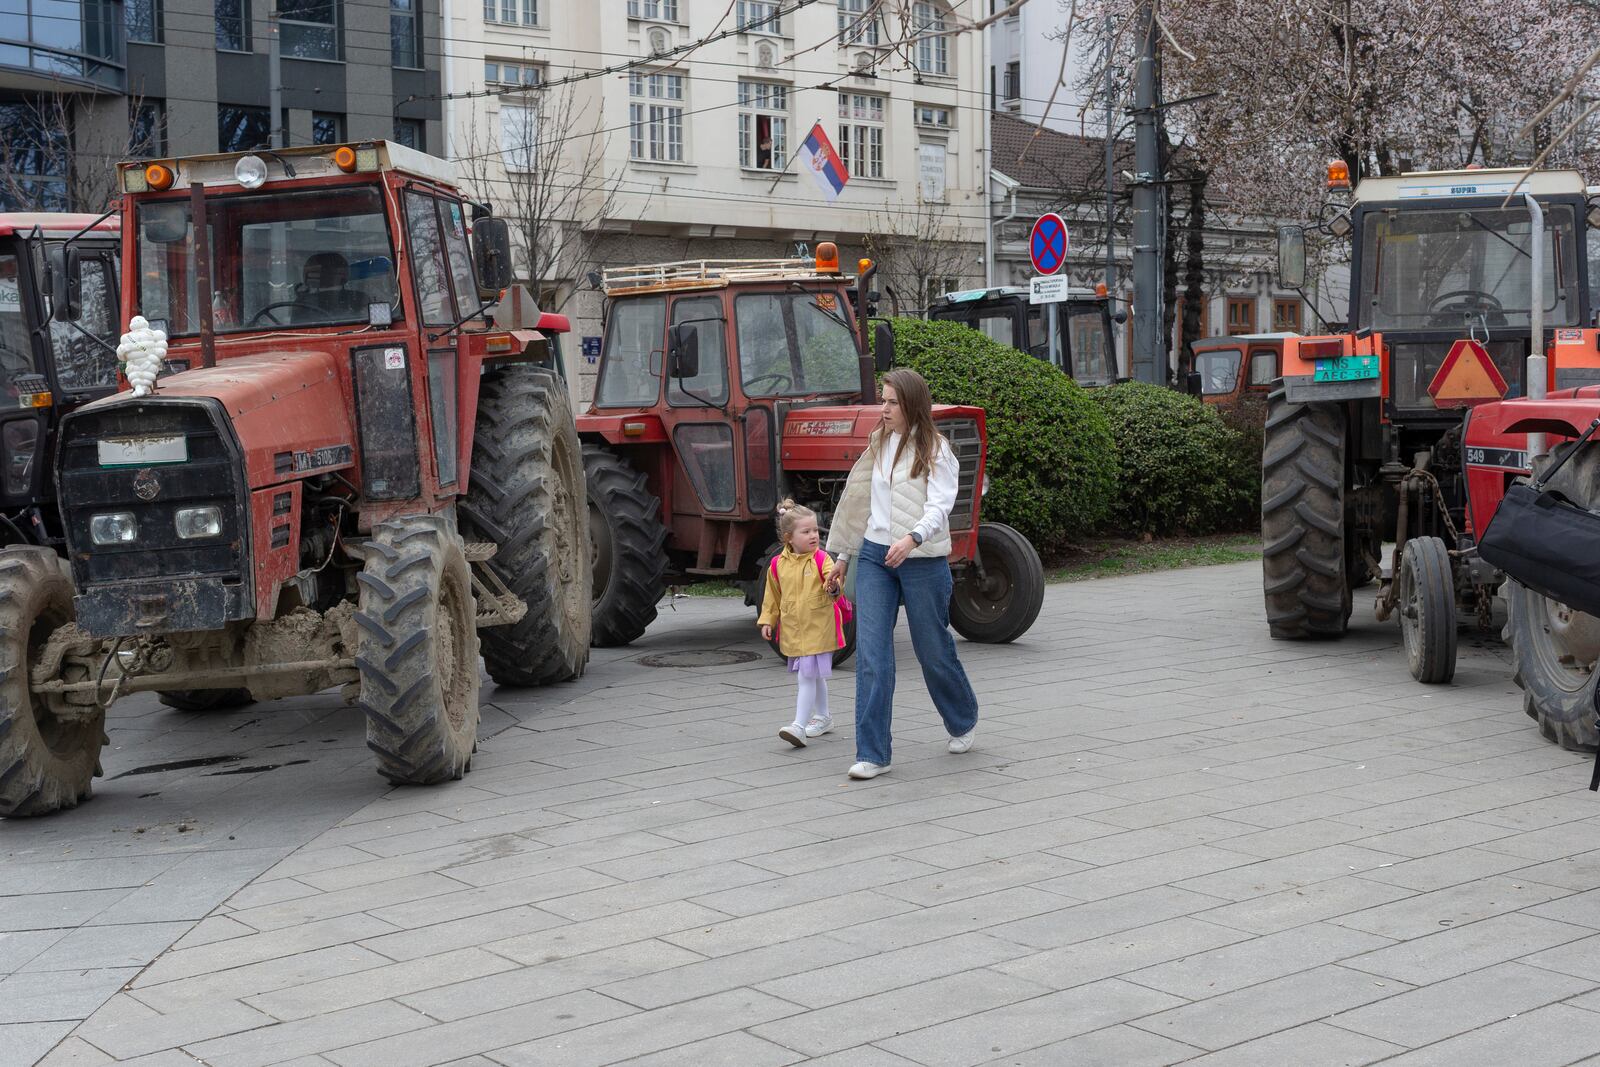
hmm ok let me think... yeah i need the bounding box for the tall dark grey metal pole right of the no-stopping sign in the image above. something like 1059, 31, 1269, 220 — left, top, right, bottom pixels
1133, 0, 1166, 386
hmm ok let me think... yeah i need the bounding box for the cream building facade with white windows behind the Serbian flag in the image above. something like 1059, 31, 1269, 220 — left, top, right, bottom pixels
445, 0, 989, 398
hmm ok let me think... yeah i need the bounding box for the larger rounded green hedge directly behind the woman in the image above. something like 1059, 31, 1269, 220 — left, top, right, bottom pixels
893, 318, 1117, 552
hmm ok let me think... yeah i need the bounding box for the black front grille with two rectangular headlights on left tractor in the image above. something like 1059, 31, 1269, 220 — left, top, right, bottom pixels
59, 400, 250, 590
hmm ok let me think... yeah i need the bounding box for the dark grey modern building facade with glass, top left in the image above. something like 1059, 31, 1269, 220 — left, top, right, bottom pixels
0, 0, 443, 210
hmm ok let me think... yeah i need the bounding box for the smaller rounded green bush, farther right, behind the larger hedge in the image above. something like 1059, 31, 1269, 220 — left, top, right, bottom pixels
1094, 382, 1261, 536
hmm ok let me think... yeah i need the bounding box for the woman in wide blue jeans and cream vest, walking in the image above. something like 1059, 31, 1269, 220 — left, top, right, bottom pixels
827, 368, 978, 777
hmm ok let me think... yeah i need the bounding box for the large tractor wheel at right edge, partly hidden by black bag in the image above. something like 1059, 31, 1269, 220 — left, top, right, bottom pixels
1501, 445, 1600, 752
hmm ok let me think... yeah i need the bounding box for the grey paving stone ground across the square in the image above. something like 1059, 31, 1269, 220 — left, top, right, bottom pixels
9, 565, 1600, 1067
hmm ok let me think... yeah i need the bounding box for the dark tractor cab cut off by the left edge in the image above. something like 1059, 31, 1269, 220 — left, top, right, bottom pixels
0, 213, 120, 545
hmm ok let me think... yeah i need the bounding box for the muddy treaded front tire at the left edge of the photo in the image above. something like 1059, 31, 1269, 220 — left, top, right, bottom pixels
0, 547, 106, 817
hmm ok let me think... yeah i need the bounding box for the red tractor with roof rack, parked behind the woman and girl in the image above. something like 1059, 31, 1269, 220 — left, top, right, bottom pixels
578, 243, 1045, 654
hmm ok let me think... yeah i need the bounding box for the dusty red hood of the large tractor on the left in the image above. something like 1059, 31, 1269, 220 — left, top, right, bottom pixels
83, 350, 355, 490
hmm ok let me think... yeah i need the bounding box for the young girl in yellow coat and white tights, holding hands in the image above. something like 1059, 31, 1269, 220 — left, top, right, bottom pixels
755, 501, 845, 749
